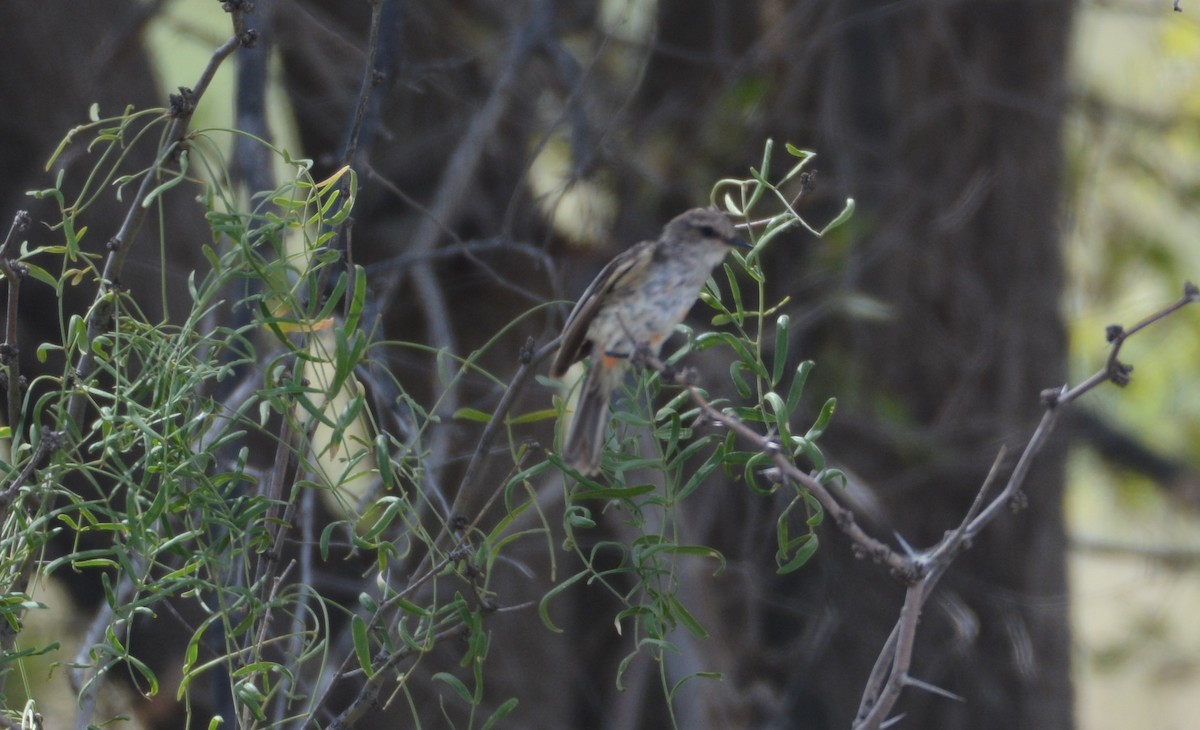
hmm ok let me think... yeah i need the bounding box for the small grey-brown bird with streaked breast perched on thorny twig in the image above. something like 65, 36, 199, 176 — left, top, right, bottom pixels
550, 208, 746, 475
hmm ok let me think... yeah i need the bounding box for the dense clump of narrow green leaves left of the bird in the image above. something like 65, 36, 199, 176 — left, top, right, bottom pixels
0, 103, 486, 726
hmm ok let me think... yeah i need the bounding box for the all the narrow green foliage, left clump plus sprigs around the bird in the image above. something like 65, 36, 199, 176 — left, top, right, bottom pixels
0, 90, 851, 728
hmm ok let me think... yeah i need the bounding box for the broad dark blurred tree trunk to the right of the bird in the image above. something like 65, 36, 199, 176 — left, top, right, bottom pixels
758, 1, 1073, 729
